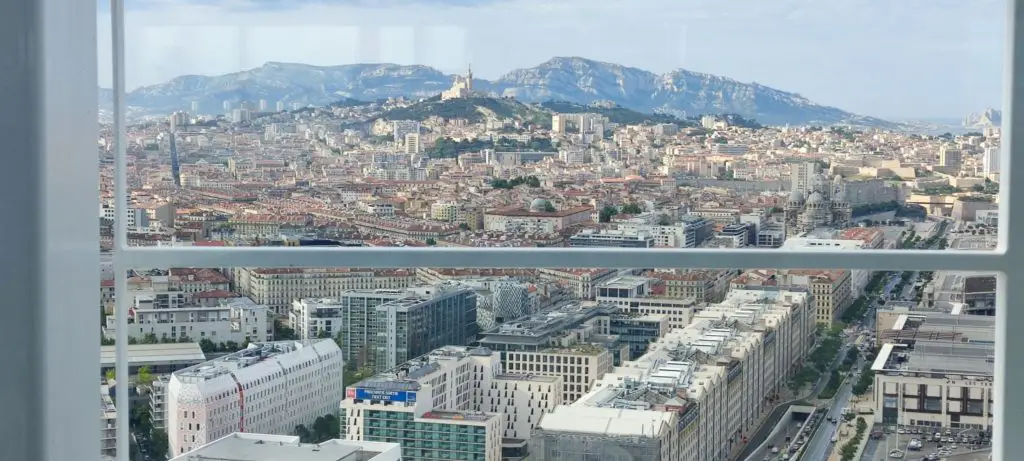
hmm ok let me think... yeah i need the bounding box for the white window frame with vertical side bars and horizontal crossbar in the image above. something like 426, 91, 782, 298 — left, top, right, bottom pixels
101, 0, 1024, 461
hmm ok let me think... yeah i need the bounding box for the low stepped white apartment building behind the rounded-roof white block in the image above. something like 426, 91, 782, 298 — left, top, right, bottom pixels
103, 291, 273, 344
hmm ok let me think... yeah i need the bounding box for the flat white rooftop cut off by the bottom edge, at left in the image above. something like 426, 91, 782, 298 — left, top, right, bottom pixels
171, 432, 401, 461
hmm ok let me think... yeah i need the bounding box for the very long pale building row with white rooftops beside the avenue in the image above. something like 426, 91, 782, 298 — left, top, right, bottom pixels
530, 290, 813, 461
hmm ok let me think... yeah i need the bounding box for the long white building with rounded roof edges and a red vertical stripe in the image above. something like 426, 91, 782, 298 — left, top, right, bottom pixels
167, 339, 344, 455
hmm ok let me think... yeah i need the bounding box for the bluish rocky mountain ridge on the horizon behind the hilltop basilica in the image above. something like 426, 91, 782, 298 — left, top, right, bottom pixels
100, 56, 899, 129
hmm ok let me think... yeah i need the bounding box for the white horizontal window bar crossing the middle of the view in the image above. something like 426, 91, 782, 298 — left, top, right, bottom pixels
116, 247, 1007, 271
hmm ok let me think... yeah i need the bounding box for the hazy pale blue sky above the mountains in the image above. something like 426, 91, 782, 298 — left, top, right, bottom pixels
98, 0, 1006, 118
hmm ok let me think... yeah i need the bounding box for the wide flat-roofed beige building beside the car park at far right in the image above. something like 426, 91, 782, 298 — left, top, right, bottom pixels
871, 311, 995, 430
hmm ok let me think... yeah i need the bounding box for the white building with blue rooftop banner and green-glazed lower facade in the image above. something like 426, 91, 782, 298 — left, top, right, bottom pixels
341, 346, 512, 461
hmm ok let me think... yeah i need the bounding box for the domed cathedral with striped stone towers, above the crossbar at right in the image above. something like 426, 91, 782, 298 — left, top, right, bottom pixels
784, 173, 853, 236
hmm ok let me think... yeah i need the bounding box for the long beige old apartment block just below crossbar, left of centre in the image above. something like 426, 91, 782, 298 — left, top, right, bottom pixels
233, 267, 416, 316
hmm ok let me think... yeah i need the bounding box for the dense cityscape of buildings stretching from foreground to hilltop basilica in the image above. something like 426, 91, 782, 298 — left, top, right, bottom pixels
98, 64, 999, 461
